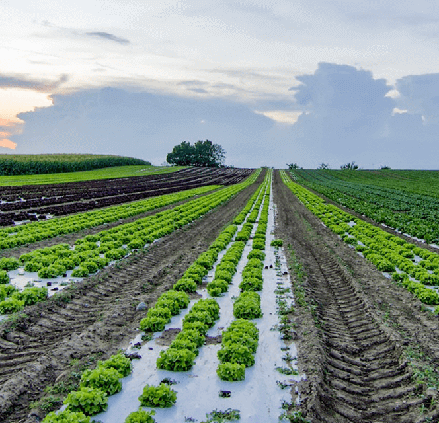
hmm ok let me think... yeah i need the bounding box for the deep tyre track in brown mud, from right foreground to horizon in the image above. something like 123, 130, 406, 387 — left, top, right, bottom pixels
275, 172, 434, 423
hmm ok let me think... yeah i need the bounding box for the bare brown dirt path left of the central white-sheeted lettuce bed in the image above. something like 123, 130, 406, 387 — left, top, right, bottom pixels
0, 172, 265, 423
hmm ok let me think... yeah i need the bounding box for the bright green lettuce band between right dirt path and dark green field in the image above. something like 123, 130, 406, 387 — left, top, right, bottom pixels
281, 171, 439, 312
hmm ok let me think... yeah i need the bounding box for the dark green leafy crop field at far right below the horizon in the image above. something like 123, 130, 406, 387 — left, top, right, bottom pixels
294, 169, 439, 244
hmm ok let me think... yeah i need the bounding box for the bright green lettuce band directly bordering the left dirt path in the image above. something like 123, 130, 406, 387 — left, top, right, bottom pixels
0, 170, 260, 314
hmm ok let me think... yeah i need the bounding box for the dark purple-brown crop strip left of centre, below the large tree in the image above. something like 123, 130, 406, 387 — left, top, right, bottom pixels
0, 168, 251, 226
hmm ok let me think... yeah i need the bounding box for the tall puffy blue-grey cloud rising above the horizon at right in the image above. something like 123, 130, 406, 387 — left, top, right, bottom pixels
290, 63, 439, 169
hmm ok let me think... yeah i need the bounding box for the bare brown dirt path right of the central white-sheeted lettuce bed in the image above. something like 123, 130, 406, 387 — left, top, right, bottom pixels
273, 171, 439, 423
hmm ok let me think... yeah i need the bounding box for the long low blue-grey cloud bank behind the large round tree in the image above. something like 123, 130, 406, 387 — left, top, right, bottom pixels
11, 88, 276, 167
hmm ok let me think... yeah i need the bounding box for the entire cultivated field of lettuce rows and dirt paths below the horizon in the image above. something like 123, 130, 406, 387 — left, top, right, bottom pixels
0, 167, 439, 423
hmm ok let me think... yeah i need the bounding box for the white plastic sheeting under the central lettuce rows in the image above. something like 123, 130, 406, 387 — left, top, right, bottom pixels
94, 183, 302, 423
